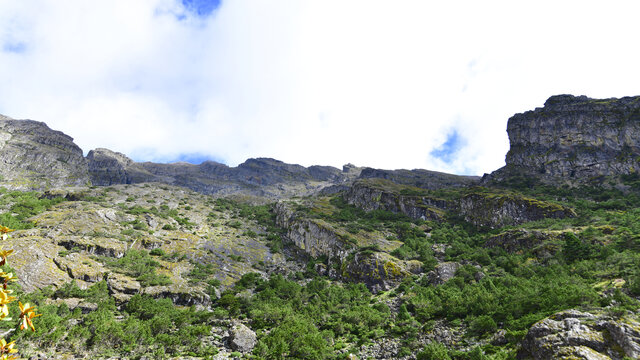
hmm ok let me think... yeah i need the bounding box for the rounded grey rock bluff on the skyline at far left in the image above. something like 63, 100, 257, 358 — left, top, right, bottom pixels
0, 117, 89, 190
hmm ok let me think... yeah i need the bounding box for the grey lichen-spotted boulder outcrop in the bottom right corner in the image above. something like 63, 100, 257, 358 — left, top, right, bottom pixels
518, 310, 640, 360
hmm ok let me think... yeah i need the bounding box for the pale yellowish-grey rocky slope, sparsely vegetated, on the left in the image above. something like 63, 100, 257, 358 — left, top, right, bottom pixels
3, 184, 286, 305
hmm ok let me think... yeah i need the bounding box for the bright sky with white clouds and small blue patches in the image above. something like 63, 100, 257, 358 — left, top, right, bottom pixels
0, 0, 640, 175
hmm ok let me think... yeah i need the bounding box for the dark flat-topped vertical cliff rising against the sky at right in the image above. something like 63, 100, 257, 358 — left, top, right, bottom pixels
491, 95, 640, 183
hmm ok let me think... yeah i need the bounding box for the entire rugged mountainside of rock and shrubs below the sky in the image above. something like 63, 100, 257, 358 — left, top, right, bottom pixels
0, 95, 640, 360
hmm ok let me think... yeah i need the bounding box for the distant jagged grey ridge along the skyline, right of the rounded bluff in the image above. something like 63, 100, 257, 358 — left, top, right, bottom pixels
87, 149, 357, 198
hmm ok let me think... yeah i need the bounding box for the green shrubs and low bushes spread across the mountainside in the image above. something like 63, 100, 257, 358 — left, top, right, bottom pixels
5, 176, 640, 360
